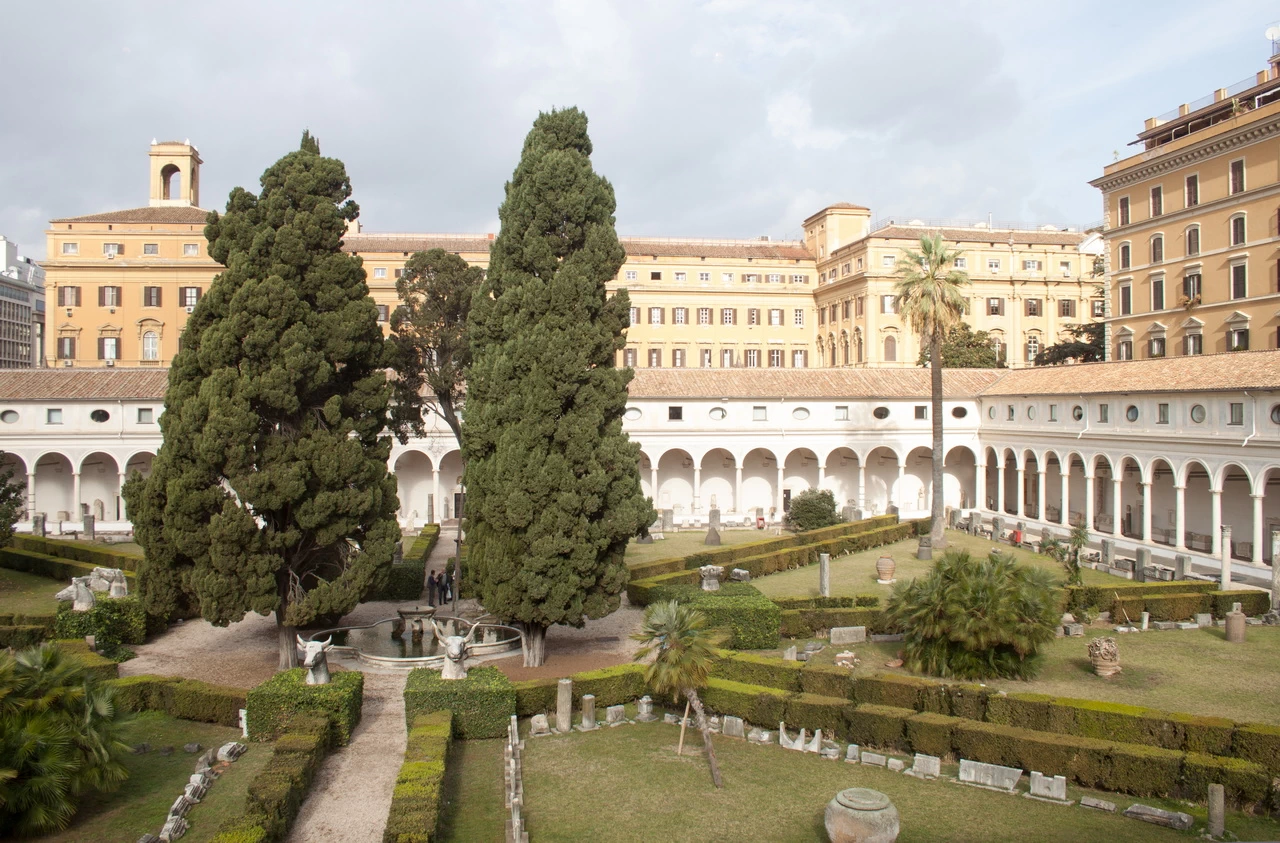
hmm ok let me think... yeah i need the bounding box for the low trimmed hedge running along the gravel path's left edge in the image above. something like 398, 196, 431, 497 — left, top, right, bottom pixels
210, 711, 340, 843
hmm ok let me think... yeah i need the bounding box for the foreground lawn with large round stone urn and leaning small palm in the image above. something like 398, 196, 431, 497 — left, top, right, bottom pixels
524, 723, 1280, 843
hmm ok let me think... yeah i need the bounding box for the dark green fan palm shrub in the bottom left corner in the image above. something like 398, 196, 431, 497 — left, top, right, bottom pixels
0, 643, 128, 838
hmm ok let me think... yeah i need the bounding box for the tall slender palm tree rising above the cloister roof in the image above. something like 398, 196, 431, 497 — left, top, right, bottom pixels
893, 234, 969, 548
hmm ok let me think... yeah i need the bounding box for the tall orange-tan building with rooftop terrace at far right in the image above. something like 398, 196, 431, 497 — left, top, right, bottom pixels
1091, 49, 1280, 359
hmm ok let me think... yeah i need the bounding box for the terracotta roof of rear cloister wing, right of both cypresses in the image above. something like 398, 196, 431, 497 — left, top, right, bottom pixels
630, 367, 1001, 399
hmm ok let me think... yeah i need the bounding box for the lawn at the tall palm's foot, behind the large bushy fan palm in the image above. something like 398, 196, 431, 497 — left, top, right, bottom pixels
751, 530, 1126, 597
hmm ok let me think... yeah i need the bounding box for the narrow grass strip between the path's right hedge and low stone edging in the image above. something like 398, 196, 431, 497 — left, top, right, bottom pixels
440, 739, 507, 843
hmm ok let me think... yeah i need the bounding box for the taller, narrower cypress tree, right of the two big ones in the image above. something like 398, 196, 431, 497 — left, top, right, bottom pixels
462, 109, 653, 666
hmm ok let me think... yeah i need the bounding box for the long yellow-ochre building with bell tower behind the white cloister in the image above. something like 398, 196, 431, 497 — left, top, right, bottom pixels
45, 142, 1101, 368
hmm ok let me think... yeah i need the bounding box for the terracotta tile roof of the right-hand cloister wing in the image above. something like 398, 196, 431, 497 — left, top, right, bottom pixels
982, 349, 1280, 397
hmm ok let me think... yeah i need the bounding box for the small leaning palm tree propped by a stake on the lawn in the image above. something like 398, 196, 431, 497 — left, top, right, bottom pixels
631, 600, 724, 788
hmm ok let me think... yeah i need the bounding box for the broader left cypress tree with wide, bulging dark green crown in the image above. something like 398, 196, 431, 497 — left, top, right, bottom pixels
124, 133, 399, 669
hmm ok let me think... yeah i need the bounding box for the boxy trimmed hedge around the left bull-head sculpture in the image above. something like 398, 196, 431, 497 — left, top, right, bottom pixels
244, 668, 365, 746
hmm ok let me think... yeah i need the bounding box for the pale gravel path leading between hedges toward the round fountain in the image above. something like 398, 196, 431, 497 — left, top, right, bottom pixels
285, 672, 408, 843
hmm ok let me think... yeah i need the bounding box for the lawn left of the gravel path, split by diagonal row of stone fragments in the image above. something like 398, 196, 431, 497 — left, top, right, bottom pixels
36, 711, 271, 843
